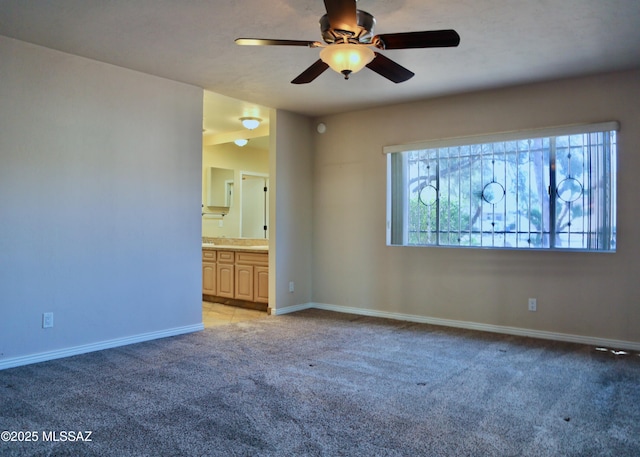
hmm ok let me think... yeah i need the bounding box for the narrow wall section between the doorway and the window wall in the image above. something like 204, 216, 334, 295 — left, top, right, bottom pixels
269, 110, 313, 313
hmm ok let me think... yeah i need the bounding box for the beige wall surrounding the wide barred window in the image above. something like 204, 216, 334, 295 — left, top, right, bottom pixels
312, 68, 640, 343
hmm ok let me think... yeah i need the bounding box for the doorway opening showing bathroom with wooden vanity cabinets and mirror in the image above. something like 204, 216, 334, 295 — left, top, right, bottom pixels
202, 91, 271, 326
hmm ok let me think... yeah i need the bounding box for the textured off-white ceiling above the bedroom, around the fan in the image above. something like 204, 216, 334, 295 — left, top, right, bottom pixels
0, 0, 640, 123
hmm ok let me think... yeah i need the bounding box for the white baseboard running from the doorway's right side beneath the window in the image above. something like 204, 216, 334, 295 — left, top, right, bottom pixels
284, 303, 640, 352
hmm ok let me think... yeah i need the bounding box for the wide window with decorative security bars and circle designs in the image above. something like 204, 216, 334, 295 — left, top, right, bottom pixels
384, 122, 618, 252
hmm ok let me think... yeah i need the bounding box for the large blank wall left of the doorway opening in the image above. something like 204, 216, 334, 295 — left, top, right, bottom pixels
0, 37, 202, 368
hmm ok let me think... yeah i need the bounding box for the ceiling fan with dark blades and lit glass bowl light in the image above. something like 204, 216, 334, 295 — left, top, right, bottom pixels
235, 0, 460, 84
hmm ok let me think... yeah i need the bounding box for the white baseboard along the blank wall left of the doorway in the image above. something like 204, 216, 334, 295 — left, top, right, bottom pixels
0, 323, 204, 370
